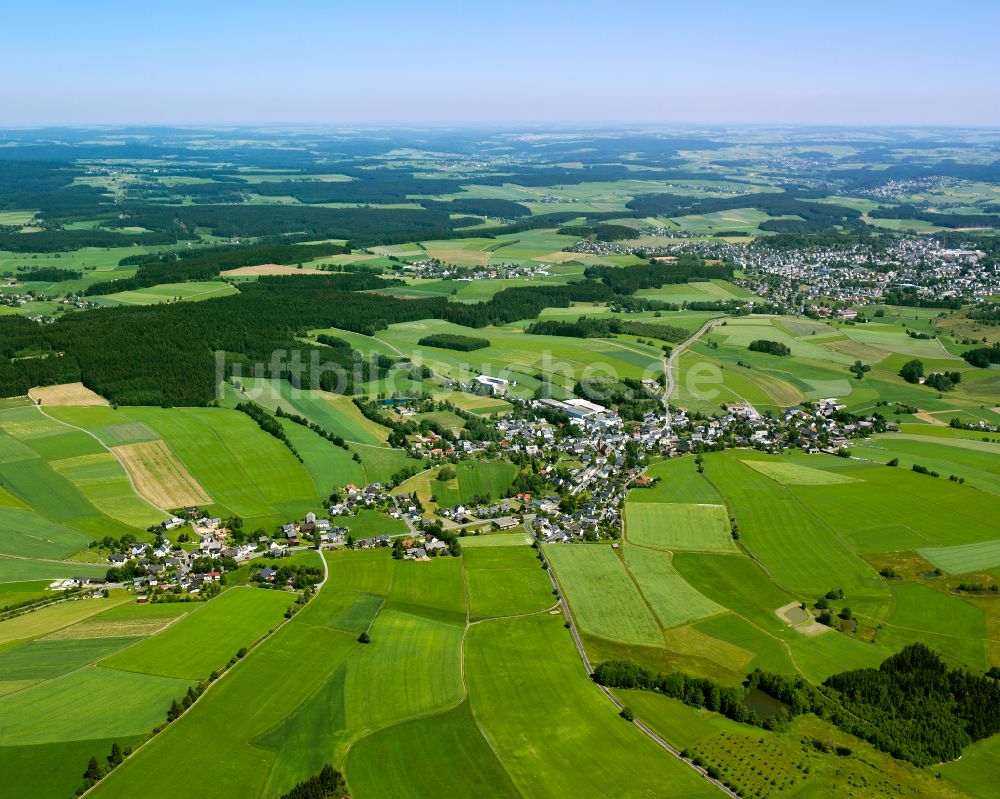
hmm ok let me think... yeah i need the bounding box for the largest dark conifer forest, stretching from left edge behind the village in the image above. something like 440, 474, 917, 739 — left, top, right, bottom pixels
0, 272, 628, 405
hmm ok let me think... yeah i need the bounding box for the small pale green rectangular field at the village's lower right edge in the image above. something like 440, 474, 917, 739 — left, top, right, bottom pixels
625, 504, 737, 552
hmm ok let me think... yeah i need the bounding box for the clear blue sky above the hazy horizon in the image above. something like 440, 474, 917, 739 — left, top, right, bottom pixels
0, 0, 1000, 126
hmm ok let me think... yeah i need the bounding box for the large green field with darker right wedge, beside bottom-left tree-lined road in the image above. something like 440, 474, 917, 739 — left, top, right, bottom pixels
86, 621, 360, 799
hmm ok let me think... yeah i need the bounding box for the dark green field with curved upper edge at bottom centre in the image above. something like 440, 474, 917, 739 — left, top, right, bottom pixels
346, 702, 521, 799
